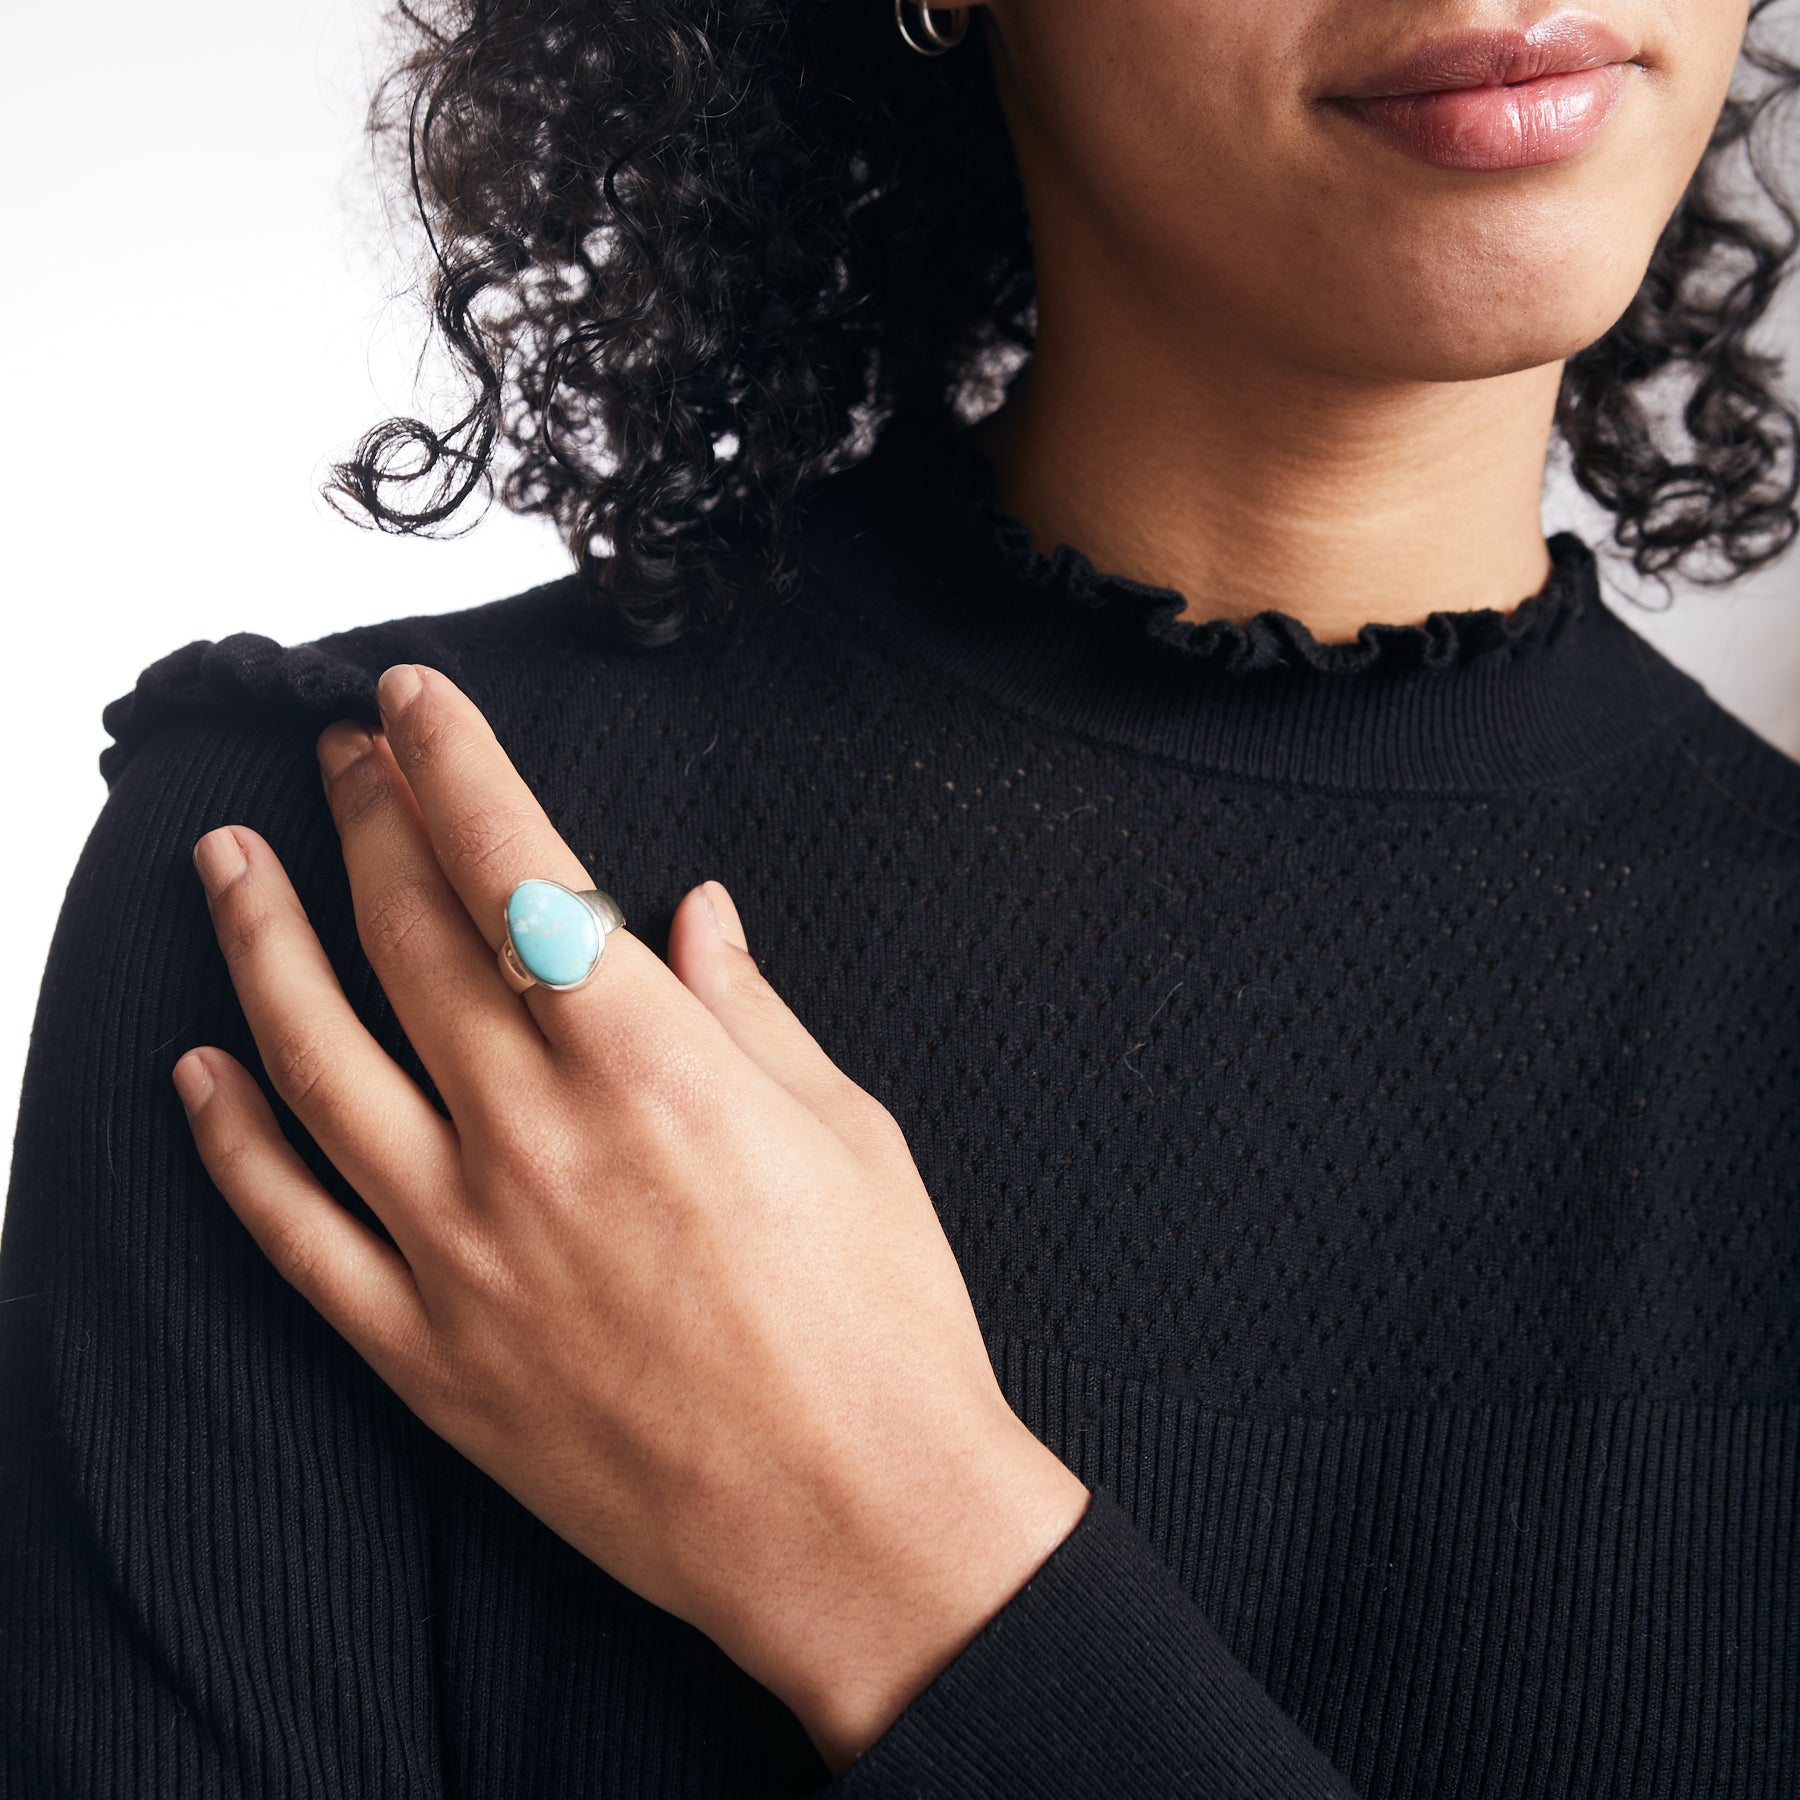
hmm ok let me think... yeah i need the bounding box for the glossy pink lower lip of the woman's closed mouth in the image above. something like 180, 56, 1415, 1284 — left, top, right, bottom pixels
1336, 63, 1631, 169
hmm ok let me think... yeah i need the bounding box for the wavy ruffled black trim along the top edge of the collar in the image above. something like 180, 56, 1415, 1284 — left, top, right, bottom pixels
928, 416, 1593, 677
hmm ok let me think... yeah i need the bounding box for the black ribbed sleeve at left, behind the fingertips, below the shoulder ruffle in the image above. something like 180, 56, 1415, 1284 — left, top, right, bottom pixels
0, 676, 441, 1800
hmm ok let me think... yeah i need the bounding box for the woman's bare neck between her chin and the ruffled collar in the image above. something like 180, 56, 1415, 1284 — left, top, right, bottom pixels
970, 254, 1561, 643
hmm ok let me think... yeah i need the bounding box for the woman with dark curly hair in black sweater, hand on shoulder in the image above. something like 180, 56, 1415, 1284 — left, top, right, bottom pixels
0, 0, 1800, 1796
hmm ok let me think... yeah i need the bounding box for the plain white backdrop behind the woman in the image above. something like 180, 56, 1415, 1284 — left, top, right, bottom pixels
0, 0, 1800, 1209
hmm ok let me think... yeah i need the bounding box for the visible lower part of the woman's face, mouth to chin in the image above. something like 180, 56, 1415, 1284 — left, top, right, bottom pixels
988, 0, 1750, 382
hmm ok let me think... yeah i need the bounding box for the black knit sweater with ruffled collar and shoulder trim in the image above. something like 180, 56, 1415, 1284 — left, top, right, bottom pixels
0, 412, 1800, 1800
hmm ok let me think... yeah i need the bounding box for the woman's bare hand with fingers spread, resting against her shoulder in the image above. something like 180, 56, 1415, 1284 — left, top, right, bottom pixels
176, 664, 1087, 1769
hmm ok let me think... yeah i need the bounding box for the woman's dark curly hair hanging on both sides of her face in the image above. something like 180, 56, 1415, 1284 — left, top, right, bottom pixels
328, 0, 1800, 646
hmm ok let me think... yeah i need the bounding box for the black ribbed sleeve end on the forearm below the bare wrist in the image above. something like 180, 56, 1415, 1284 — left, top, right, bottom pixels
823, 1489, 1355, 1800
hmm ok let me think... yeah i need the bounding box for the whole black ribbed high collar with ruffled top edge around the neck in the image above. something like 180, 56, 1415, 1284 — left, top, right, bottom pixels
801, 414, 1706, 794
